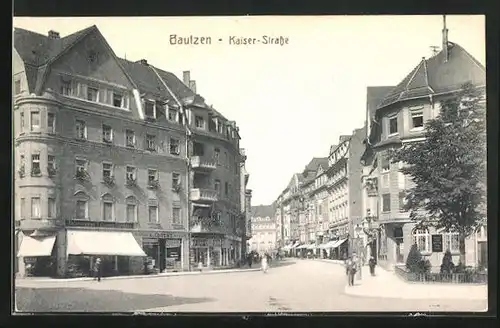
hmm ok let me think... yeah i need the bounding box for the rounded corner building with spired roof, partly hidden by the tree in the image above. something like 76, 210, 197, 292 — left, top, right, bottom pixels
363, 28, 487, 269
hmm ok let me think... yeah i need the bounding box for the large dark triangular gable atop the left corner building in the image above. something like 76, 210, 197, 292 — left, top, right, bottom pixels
45, 29, 134, 89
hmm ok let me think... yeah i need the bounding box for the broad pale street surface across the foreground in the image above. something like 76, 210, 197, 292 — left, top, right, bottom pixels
16, 260, 487, 312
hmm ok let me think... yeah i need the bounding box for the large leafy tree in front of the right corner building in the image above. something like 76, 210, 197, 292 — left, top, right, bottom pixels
391, 83, 486, 263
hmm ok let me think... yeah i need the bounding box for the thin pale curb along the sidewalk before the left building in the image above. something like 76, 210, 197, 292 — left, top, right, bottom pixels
15, 268, 260, 283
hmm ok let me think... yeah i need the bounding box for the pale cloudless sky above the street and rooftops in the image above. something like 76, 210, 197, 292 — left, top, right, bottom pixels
13, 15, 485, 205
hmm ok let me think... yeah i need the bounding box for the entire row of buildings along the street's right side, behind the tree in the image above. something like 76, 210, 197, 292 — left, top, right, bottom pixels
275, 24, 487, 268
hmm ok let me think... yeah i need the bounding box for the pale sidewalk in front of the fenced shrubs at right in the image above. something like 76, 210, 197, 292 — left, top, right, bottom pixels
345, 266, 488, 300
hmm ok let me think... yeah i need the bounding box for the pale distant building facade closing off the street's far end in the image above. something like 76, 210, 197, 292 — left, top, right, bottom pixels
250, 204, 277, 254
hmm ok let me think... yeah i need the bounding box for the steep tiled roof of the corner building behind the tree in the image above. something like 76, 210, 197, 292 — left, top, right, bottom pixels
378, 42, 486, 108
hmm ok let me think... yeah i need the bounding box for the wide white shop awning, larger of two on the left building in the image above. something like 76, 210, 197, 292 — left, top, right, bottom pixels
67, 230, 146, 256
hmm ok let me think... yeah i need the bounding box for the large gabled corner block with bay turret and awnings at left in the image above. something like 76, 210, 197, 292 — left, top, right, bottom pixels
13, 26, 251, 276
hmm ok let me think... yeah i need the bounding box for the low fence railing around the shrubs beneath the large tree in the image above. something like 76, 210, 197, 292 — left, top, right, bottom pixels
394, 266, 488, 284
